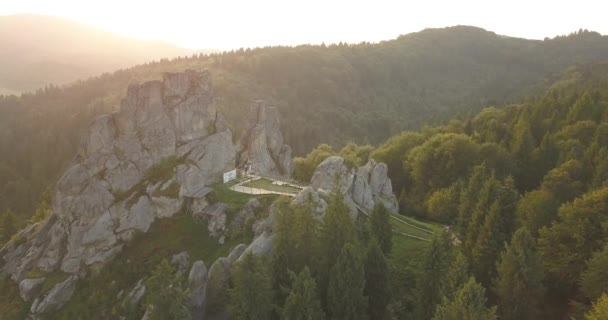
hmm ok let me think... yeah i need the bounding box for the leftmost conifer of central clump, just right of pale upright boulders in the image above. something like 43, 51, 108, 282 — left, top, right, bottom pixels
230, 253, 273, 320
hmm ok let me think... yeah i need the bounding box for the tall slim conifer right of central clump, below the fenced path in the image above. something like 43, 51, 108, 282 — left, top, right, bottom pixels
416, 232, 452, 319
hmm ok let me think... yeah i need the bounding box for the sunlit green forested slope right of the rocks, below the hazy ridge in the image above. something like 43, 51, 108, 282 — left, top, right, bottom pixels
295, 65, 608, 319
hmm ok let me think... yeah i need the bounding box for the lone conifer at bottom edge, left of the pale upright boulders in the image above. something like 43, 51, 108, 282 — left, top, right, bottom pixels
146, 259, 190, 320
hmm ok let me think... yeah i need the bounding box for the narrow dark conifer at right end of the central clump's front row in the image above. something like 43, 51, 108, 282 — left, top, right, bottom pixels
364, 240, 391, 320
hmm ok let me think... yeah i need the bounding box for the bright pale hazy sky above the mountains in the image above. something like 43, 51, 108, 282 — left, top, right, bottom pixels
0, 0, 608, 49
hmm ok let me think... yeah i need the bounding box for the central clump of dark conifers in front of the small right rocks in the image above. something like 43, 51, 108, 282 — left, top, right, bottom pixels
227, 190, 392, 320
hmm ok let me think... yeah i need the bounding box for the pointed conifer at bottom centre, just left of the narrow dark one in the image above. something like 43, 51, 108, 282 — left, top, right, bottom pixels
327, 244, 368, 320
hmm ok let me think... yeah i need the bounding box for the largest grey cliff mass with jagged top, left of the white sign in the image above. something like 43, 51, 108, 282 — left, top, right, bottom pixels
0, 71, 236, 282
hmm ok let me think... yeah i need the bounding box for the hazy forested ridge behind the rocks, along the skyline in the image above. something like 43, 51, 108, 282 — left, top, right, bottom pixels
0, 27, 608, 225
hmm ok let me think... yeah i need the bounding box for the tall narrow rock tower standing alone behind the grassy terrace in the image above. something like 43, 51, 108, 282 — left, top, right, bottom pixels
237, 101, 292, 177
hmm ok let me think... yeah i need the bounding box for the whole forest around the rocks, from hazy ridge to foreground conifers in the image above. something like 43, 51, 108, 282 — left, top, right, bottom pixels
0, 27, 608, 320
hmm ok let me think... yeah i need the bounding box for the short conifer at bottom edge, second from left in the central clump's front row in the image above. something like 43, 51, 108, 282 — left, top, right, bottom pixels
281, 267, 325, 320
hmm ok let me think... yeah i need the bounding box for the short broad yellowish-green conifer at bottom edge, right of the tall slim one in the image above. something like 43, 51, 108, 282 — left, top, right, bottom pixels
433, 277, 496, 320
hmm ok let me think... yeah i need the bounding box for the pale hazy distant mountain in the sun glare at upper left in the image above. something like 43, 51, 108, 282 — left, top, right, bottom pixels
0, 15, 192, 94
